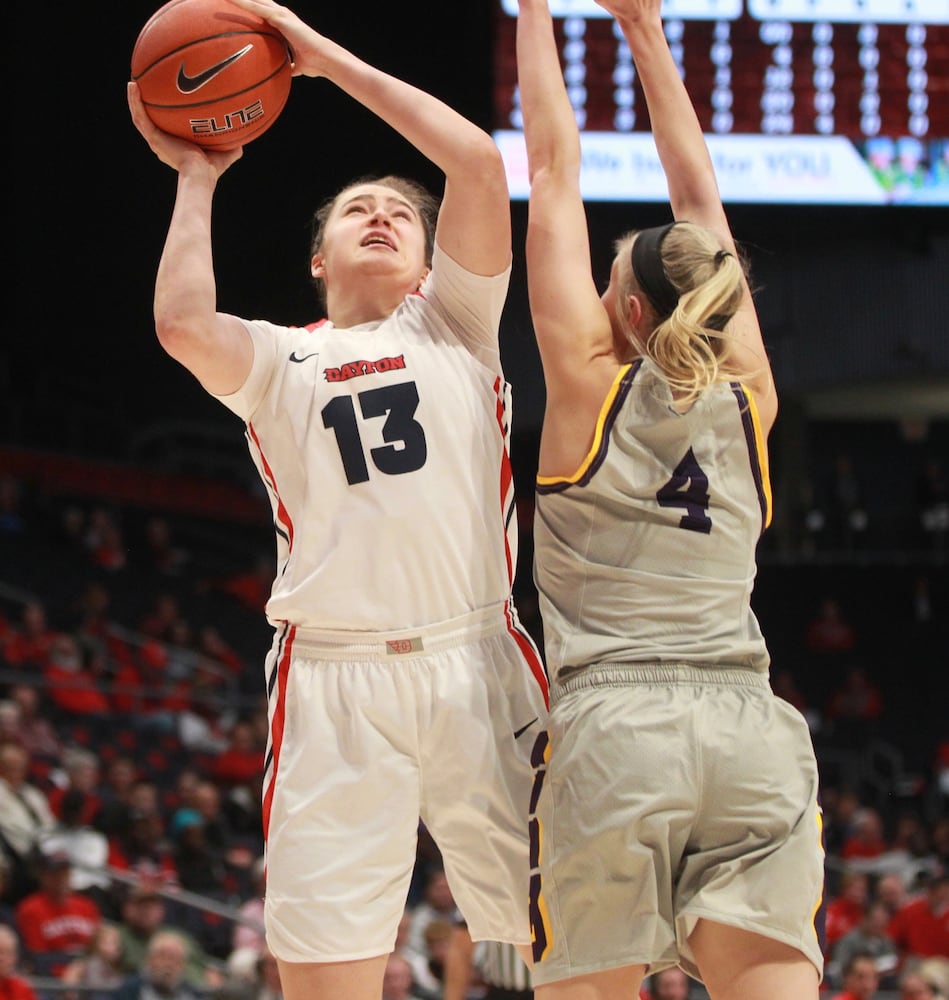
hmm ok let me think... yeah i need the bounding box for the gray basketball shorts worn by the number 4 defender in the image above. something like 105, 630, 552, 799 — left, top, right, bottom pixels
530, 664, 824, 985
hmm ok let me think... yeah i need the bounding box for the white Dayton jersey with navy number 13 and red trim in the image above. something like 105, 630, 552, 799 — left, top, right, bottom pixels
218, 247, 517, 632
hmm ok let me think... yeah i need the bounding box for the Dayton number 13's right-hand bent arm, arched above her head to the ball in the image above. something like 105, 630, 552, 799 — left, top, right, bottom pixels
228, 0, 511, 275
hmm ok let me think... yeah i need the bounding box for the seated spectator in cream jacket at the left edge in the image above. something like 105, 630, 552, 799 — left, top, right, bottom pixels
0, 743, 56, 902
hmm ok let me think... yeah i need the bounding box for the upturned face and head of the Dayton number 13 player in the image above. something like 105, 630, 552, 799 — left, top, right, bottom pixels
313, 184, 426, 292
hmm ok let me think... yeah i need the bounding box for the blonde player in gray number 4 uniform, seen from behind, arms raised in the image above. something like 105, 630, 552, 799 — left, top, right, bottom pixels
517, 0, 823, 1000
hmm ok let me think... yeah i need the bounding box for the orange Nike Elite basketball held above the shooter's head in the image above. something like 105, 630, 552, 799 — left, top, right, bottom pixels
132, 0, 291, 149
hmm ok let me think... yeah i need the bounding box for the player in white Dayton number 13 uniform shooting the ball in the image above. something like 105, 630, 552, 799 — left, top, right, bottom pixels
129, 0, 546, 1000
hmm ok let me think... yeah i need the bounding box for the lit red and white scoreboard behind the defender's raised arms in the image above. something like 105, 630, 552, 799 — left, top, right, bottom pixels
494, 0, 949, 206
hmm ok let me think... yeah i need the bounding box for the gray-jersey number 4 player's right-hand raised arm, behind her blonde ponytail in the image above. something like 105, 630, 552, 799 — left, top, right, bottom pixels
597, 0, 777, 422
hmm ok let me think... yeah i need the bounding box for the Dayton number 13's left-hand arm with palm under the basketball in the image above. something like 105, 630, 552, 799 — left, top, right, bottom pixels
128, 83, 253, 395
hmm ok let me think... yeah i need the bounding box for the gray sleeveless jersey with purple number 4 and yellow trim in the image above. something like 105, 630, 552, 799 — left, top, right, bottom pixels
534, 361, 771, 686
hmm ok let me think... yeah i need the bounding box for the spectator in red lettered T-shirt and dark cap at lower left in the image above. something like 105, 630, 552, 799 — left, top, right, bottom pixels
16, 851, 102, 976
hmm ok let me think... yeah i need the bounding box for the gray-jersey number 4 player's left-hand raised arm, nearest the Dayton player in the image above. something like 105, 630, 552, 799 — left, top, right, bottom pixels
517, 0, 614, 380
